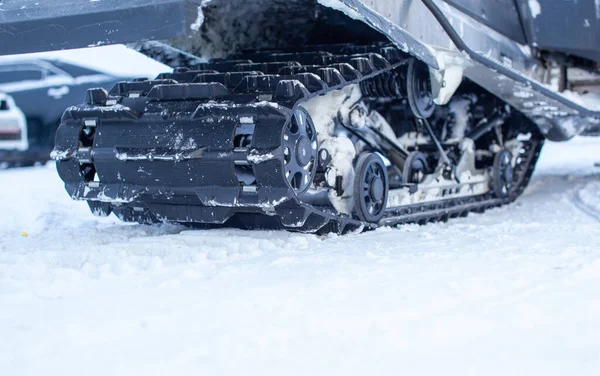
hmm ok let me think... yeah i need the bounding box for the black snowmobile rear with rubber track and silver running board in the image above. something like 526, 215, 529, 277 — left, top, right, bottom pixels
0, 0, 600, 233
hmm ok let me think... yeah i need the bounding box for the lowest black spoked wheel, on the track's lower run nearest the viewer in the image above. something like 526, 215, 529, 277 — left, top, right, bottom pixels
353, 153, 389, 223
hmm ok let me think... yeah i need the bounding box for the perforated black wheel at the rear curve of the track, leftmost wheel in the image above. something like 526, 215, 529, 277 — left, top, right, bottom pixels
282, 108, 319, 194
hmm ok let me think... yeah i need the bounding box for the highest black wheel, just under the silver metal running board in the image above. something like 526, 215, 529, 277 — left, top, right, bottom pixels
406, 59, 435, 119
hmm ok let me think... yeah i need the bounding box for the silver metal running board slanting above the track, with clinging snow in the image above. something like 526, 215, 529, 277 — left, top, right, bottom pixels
330, 0, 600, 140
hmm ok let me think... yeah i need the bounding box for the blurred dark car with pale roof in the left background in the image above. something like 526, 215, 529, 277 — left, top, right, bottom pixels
0, 58, 131, 165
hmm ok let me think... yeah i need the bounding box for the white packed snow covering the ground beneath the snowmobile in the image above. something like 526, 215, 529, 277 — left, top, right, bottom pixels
0, 138, 600, 376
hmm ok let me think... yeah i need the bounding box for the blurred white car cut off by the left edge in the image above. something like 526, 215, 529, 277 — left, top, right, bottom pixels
0, 93, 29, 152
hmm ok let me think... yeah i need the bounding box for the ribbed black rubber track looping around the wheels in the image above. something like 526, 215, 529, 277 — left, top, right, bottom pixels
55, 44, 543, 233
